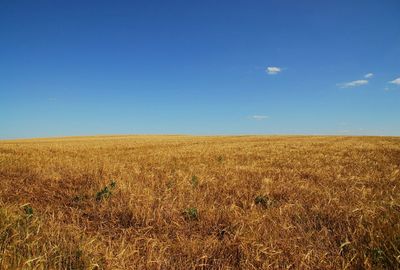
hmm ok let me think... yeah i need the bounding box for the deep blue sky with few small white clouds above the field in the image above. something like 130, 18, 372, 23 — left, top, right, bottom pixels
0, 0, 400, 138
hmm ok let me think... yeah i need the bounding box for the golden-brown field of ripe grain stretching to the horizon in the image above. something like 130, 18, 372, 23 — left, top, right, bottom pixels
0, 136, 400, 269
